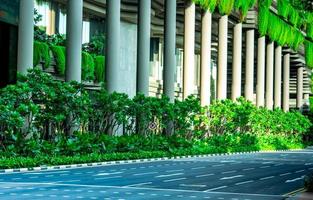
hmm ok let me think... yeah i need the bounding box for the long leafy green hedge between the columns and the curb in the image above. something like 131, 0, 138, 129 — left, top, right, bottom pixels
0, 69, 311, 163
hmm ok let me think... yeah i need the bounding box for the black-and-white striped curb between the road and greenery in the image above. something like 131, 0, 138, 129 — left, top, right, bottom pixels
0, 149, 301, 174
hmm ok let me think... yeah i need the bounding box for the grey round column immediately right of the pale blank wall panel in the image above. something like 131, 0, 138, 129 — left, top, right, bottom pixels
137, 0, 151, 96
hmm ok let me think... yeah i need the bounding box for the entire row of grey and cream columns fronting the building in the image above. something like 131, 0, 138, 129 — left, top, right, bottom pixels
18, 0, 303, 111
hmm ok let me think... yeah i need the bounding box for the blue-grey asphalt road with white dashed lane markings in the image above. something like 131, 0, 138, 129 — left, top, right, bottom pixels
0, 150, 313, 200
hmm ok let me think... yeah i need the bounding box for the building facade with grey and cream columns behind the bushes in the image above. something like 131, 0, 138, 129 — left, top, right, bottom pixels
0, 0, 311, 111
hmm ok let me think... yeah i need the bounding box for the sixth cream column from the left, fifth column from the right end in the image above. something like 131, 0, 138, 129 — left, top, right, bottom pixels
256, 36, 265, 107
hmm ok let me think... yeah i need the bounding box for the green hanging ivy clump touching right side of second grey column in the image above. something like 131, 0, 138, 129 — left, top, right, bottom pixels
82, 51, 95, 81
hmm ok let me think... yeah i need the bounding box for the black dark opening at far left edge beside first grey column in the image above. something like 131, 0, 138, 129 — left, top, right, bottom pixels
0, 21, 17, 88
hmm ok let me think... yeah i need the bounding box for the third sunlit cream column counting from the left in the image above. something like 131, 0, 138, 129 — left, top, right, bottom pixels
217, 15, 228, 100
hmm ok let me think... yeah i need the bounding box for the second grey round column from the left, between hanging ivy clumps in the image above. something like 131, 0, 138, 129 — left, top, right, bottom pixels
65, 0, 83, 82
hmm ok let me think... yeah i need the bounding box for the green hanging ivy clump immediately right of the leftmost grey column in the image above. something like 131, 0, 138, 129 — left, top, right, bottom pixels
33, 41, 51, 68
